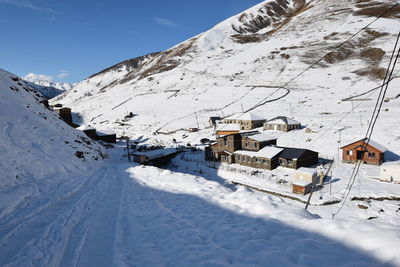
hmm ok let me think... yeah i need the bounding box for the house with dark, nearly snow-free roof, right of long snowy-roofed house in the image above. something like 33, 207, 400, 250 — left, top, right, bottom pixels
279, 147, 318, 169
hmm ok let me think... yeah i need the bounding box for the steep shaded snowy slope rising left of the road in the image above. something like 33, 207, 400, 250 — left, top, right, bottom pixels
0, 69, 103, 192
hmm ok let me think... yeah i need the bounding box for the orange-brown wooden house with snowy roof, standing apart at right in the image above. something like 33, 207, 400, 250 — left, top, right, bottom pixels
341, 138, 387, 165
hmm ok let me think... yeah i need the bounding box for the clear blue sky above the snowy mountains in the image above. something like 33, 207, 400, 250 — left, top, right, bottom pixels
0, 0, 262, 82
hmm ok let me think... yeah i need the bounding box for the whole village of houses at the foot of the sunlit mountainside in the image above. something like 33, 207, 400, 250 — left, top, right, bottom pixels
50, 101, 400, 204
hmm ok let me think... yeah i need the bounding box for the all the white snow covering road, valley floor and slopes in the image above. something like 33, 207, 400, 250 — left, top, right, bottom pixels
0, 0, 400, 266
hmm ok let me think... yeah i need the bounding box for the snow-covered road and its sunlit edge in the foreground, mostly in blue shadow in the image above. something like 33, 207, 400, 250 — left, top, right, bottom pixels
0, 163, 396, 266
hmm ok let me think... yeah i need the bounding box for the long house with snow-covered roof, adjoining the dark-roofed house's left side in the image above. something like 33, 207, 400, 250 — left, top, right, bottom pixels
234, 146, 283, 170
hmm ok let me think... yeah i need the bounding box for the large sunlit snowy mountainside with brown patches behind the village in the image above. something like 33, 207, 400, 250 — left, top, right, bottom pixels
54, 0, 400, 153
